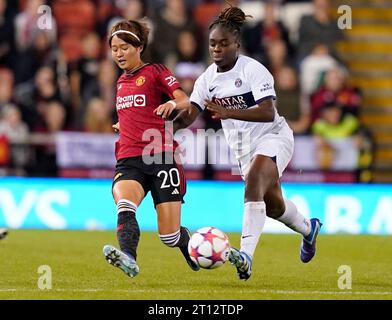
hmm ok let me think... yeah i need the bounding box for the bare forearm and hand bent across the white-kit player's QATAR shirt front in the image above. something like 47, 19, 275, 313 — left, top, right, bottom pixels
204, 97, 275, 122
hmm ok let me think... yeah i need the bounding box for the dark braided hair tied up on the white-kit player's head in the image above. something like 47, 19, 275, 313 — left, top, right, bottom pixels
208, 1, 252, 39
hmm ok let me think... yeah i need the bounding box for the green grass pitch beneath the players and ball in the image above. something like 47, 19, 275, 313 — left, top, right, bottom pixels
0, 230, 392, 300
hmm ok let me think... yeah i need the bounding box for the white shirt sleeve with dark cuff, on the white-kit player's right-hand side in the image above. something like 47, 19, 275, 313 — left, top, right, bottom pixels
245, 61, 276, 104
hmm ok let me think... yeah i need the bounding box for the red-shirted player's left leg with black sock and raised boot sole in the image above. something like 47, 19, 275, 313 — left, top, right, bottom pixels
103, 180, 145, 277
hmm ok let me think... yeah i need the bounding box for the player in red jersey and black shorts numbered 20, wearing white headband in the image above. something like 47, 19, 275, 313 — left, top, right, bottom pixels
103, 20, 199, 277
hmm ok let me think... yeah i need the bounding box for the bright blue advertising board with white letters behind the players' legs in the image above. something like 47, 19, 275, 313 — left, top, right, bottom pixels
0, 178, 392, 234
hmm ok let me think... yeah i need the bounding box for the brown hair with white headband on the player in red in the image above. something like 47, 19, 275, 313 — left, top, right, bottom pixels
108, 20, 150, 53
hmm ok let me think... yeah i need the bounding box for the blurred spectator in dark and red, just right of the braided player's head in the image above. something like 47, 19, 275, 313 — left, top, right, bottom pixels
242, 0, 293, 64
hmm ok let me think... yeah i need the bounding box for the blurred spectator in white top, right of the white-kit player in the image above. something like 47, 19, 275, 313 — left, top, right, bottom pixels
299, 43, 339, 97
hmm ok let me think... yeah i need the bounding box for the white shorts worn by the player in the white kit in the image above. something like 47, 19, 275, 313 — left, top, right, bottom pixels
238, 125, 294, 180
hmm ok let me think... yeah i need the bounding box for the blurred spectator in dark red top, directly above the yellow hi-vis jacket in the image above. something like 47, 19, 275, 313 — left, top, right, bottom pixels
310, 67, 362, 123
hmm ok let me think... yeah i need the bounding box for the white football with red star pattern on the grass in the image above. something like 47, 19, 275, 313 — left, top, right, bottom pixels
188, 227, 230, 269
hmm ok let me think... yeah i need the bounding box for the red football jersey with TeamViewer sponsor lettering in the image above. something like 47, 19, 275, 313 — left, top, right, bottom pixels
116, 64, 180, 160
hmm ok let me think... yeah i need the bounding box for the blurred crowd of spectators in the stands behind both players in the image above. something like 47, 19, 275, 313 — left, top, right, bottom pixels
0, 0, 372, 178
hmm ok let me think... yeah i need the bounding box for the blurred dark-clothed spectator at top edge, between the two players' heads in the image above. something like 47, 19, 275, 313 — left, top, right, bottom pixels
152, 0, 196, 64
